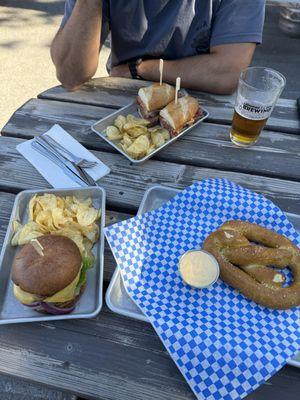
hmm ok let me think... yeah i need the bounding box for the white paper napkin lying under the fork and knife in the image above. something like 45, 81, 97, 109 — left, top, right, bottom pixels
17, 125, 110, 189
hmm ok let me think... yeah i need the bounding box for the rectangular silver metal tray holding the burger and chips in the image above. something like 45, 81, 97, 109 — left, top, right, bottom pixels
0, 186, 105, 324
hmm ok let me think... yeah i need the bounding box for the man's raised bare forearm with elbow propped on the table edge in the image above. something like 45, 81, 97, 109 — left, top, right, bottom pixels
51, 0, 102, 89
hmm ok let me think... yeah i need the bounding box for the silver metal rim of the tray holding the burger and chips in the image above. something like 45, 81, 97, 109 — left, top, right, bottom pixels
0, 186, 106, 325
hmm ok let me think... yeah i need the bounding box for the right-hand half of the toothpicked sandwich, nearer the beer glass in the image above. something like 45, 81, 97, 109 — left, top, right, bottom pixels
159, 96, 202, 137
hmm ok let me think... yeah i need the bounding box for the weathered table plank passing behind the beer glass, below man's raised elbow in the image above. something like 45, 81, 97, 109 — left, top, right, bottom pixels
39, 77, 300, 134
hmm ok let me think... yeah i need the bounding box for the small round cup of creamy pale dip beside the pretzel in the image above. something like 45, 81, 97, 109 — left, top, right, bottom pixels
179, 250, 220, 289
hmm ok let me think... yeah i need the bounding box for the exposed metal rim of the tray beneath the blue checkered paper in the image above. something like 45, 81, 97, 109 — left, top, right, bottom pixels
105, 185, 300, 368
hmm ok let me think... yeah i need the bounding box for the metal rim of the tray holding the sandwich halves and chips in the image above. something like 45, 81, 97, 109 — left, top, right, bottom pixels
91, 100, 209, 164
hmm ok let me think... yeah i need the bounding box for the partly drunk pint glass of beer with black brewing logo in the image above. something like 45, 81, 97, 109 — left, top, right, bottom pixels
230, 67, 286, 147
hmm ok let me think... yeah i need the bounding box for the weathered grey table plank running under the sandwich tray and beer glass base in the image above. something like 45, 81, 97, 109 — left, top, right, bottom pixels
2, 99, 300, 180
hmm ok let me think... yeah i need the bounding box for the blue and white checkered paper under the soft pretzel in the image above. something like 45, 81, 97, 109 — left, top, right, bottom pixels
105, 179, 300, 400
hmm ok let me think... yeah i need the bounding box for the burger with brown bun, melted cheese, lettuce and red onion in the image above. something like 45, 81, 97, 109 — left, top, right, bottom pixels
11, 235, 91, 315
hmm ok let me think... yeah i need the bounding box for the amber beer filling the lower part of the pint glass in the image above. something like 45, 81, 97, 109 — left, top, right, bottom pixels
230, 111, 268, 146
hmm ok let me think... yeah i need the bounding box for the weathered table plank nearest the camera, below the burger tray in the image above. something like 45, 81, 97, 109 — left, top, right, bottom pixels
0, 307, 300, 400
